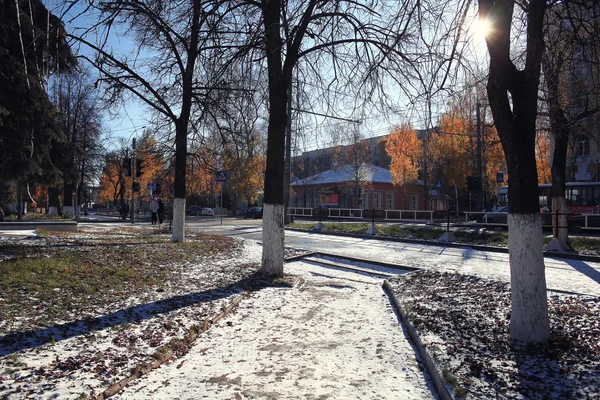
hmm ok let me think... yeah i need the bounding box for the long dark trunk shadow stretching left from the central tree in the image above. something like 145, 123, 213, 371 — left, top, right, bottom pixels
0, 271, 273, 357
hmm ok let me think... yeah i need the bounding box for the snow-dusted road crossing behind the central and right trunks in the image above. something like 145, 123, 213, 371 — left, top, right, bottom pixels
188, 219, 600, 296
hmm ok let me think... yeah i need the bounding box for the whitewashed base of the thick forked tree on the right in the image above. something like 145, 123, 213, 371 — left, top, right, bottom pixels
508, 213, 550, 343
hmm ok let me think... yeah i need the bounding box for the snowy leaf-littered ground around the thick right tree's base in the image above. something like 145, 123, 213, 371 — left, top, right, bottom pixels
389, 271, 600, 400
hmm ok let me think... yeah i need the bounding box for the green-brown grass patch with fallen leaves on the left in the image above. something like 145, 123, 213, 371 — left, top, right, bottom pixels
0, 230, 244, 334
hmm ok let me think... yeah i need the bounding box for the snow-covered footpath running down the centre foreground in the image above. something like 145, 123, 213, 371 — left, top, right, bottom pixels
115, 262, 436, 399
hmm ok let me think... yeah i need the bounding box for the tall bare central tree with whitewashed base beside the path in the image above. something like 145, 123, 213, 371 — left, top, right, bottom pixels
239, 0, 416, 276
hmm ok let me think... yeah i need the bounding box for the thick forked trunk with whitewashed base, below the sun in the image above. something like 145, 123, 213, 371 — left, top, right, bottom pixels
479, 0, 550, 342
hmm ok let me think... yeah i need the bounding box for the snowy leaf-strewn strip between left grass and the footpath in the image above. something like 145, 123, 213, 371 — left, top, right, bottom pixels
0, 237, 261, 399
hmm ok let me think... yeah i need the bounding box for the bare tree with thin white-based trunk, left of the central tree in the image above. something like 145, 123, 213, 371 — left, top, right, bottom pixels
70, 0, 236, 242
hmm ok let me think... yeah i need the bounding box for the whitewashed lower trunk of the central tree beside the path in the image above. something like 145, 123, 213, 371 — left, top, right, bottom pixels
261, 203, 285, 276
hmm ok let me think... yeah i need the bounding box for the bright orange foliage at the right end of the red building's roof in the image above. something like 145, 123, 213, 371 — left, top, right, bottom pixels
385, 125, 423, 186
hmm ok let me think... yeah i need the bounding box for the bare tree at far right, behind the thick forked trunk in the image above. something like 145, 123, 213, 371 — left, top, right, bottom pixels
542, 1, 600, 244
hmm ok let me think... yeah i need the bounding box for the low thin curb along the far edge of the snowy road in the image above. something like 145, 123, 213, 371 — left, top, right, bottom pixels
285, 228, 600, 262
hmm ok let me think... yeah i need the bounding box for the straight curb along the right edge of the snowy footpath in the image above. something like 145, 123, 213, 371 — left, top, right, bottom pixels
382, 279, 455, 400
